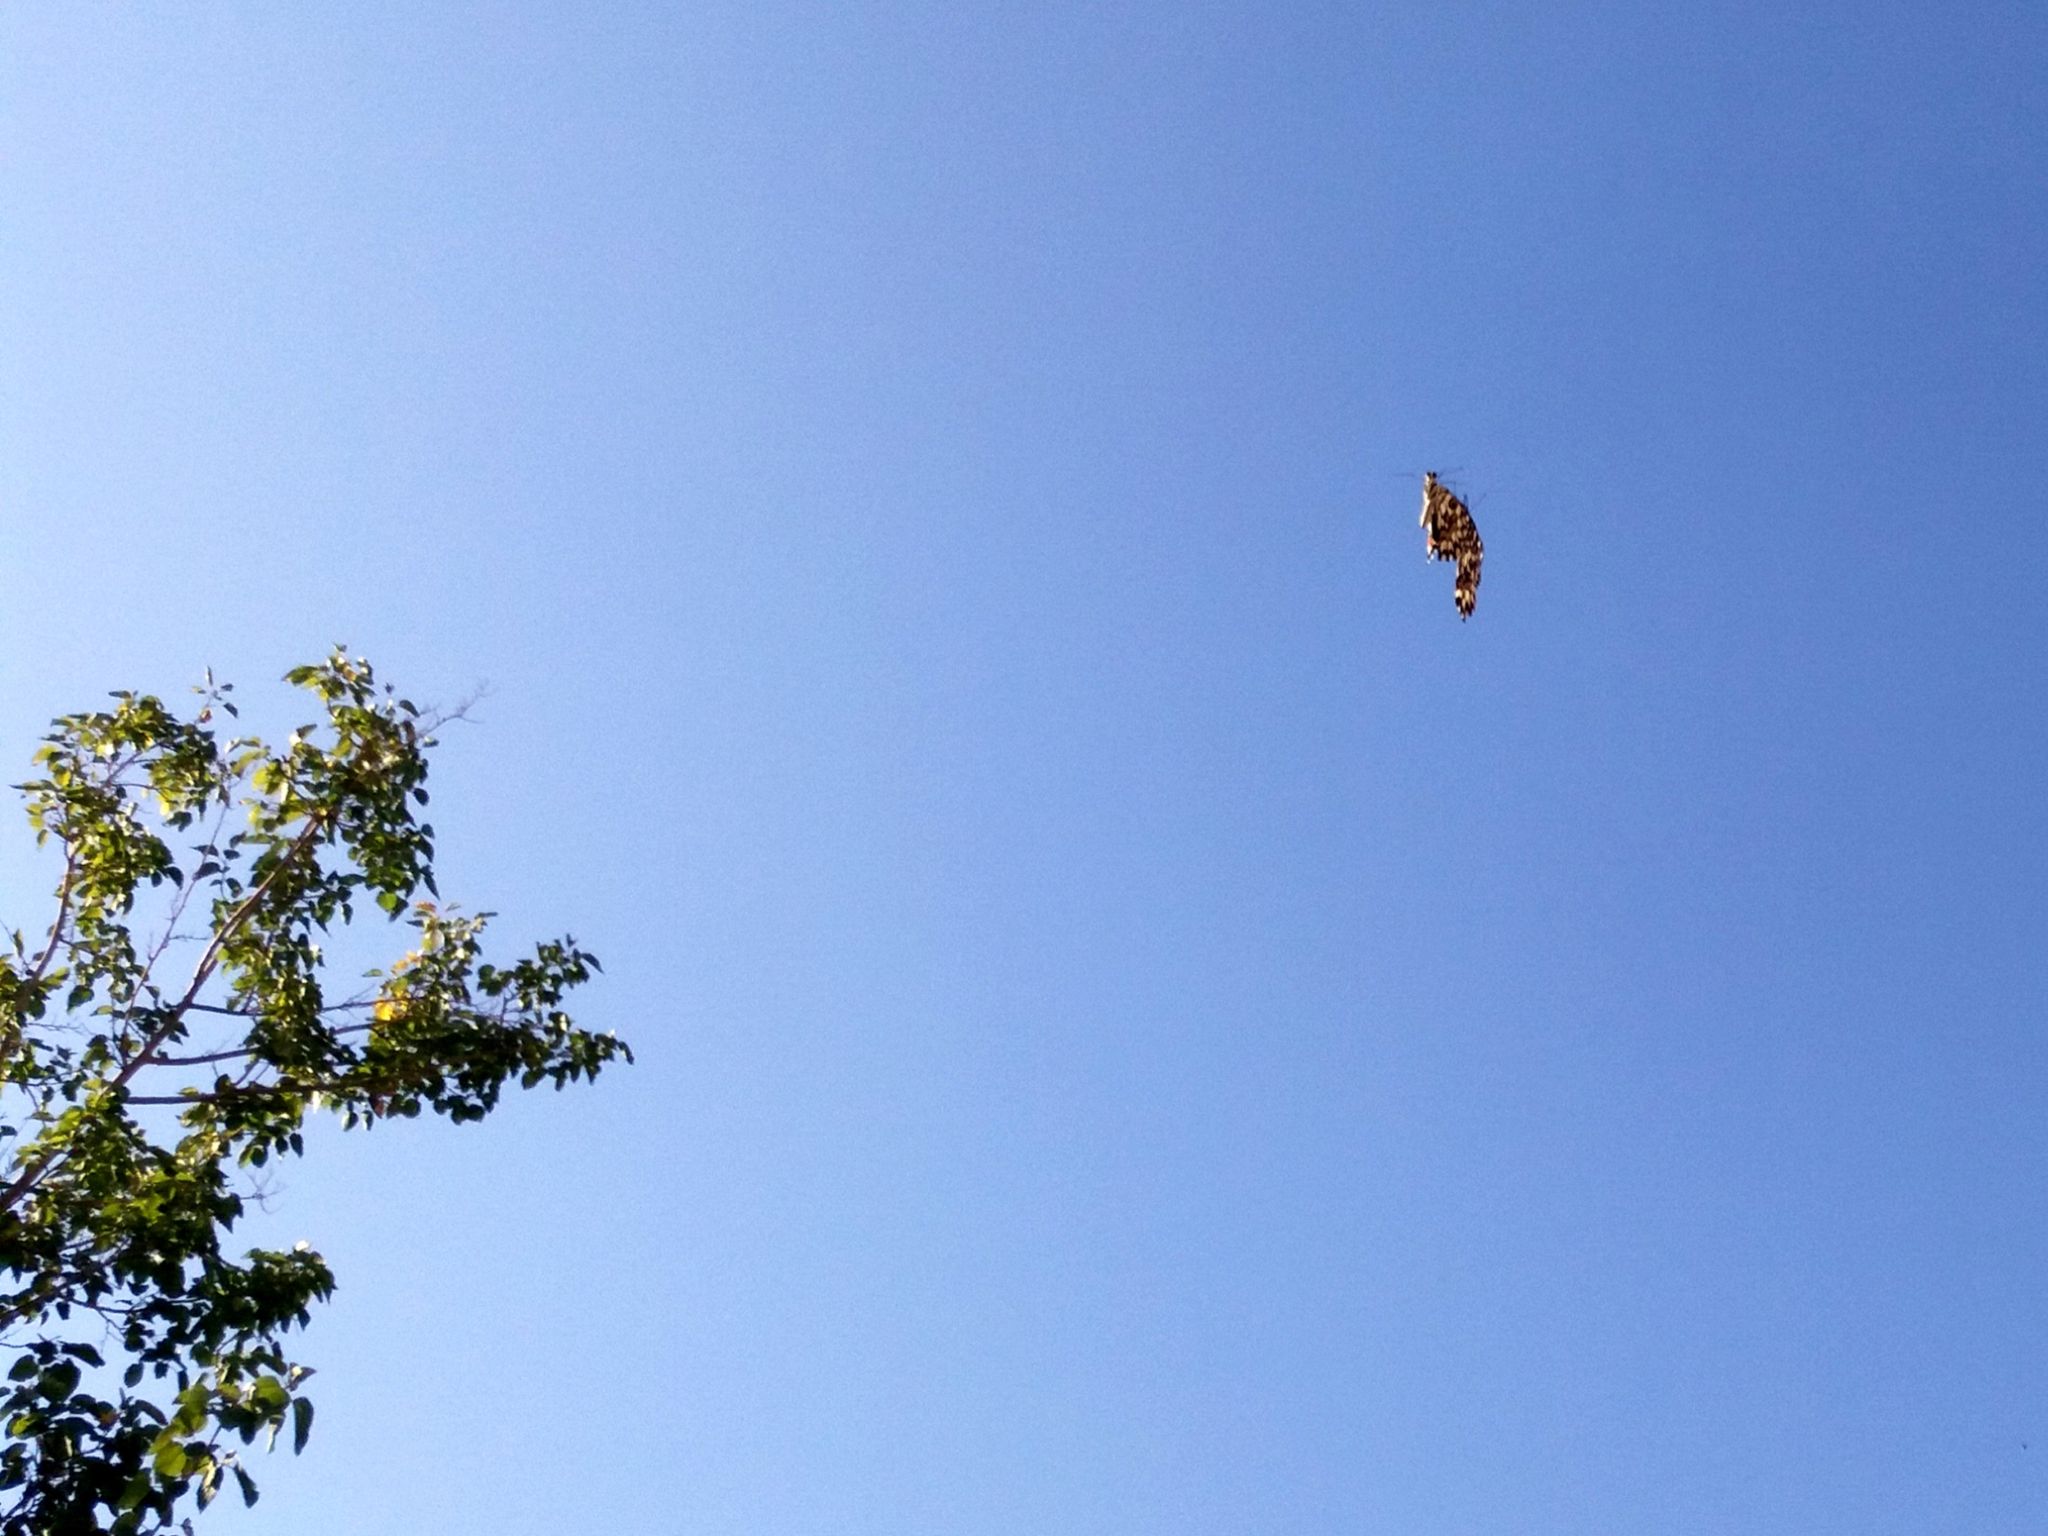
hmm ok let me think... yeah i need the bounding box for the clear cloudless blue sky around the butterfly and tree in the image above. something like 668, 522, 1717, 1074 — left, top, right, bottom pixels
0, 0, 2048, 1536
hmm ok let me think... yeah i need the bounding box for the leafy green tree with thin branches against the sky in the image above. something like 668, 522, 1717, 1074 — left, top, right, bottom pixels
0, 651, 631, 1536
